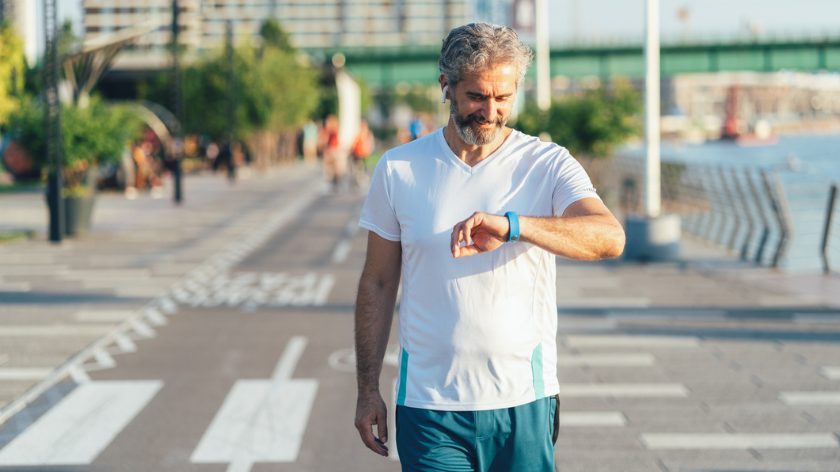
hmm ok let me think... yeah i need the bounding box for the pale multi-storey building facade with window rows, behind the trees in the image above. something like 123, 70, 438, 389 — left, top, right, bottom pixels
82, 0, 510, 68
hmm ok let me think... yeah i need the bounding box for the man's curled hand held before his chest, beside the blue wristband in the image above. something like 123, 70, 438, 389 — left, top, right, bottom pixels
451, 211, 510, 258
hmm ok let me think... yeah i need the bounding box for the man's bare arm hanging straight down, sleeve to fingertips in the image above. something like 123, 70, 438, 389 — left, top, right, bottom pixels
355, 232, 402, 456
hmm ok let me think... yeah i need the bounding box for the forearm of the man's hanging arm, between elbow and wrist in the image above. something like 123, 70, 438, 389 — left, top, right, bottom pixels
355, 274, 399, 392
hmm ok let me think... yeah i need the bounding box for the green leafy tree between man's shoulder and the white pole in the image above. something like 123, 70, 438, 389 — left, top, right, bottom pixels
517, 82, 641, 157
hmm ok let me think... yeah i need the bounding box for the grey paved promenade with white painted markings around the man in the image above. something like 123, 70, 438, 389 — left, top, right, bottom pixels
0, 161, 840, 472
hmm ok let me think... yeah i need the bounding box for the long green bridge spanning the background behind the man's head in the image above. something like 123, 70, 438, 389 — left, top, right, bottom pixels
314, 36, 840, 87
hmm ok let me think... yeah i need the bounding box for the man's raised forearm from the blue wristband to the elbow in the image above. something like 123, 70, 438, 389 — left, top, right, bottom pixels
519, 214, 624, 260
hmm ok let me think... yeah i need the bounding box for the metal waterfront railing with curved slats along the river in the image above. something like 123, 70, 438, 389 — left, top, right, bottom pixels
604, 156, 840, 273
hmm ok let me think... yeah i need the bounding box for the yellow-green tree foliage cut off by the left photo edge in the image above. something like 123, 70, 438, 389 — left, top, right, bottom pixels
0, 22, 26, 129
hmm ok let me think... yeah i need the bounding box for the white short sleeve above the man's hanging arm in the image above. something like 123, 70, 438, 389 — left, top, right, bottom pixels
359, 154, 400, 241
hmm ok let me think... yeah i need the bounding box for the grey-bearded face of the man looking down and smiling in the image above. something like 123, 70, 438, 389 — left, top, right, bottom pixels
449, 64, 518, 146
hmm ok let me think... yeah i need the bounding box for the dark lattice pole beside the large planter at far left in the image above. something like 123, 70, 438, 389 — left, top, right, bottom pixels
44, 0, 64, 243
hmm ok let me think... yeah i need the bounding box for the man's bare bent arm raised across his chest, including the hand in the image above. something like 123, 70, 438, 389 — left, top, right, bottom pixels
452, 198, 624, 260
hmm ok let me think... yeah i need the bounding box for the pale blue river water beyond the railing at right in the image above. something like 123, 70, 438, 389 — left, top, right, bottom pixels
621, 133, 840, 272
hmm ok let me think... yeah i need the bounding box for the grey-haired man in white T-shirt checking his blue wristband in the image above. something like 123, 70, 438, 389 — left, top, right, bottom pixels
356, 24, 624, 472
